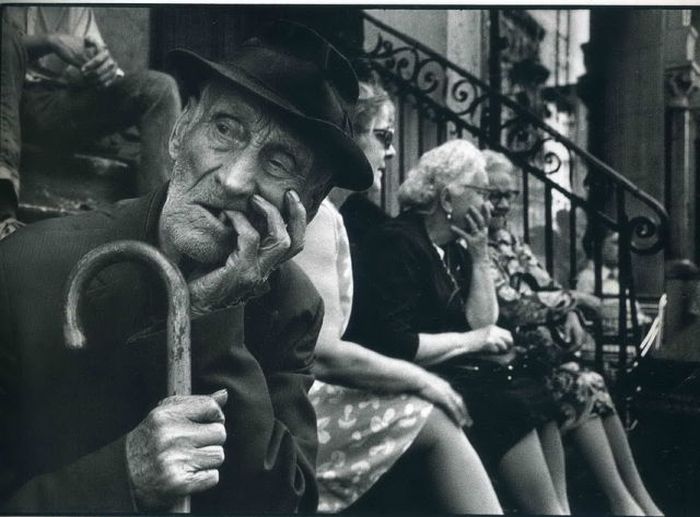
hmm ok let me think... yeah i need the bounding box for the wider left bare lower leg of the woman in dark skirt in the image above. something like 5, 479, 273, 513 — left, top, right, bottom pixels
498, 430, 565, 515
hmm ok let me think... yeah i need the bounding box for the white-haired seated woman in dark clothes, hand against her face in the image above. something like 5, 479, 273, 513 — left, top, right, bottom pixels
347, 140, 566, 514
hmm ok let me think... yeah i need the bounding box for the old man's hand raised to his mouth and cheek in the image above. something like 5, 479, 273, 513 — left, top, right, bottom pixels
188, 191, 306, 315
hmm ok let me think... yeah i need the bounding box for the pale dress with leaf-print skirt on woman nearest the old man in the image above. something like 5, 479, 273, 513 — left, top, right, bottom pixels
294, 200, 433, 513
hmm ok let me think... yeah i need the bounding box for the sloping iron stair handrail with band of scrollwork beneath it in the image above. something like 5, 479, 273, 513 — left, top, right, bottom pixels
362, 13, 678, 262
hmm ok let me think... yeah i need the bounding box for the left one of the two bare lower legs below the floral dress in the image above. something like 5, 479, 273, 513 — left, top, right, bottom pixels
570, 417, 644, 515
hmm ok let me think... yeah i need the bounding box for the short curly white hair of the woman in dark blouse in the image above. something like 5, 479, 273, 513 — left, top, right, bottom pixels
399, 139, 485, 212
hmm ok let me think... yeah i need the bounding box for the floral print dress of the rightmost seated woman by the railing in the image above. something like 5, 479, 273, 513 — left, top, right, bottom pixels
489, 230, 615, 431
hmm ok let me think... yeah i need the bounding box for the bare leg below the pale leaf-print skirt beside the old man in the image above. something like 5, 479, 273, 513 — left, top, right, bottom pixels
411, 408, 503, 515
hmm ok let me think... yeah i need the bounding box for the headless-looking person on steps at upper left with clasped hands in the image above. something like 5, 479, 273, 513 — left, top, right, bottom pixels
0, 5, 180, 239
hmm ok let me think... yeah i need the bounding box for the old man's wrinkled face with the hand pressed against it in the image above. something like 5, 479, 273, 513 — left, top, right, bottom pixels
160, 83, 324, 313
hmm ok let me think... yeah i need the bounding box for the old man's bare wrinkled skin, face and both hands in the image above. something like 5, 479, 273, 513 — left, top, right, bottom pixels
126, 78, 330, 510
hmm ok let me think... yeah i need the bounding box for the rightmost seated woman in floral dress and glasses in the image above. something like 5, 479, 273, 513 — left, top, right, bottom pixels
484, 147, 661, 515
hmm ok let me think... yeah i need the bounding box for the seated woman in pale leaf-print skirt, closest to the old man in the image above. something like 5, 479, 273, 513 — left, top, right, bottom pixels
295, 79, 502, 514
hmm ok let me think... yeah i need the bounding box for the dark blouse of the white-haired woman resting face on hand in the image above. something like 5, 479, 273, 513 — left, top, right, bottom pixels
345, 212, 471, 360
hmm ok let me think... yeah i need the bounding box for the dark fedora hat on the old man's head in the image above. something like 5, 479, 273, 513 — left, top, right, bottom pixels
168, 21, 373, 190
